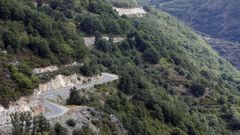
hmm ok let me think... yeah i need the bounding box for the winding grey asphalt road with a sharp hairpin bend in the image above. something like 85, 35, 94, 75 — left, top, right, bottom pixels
42, 73, 119, 119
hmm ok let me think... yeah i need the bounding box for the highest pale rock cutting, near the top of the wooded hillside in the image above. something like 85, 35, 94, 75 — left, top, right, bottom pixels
113, 7, 147, 17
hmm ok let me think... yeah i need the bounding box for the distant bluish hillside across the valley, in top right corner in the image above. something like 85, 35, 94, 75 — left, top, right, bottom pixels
140, 0, 240, 42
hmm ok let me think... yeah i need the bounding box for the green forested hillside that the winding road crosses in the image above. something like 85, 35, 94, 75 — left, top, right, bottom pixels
0, 0, 240, 135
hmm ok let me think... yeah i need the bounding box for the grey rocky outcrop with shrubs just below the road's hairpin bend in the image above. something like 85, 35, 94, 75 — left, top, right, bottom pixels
51, 106, 127, 135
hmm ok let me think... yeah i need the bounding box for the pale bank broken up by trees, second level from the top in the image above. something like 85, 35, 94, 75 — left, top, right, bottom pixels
83, 36, 126, 47
